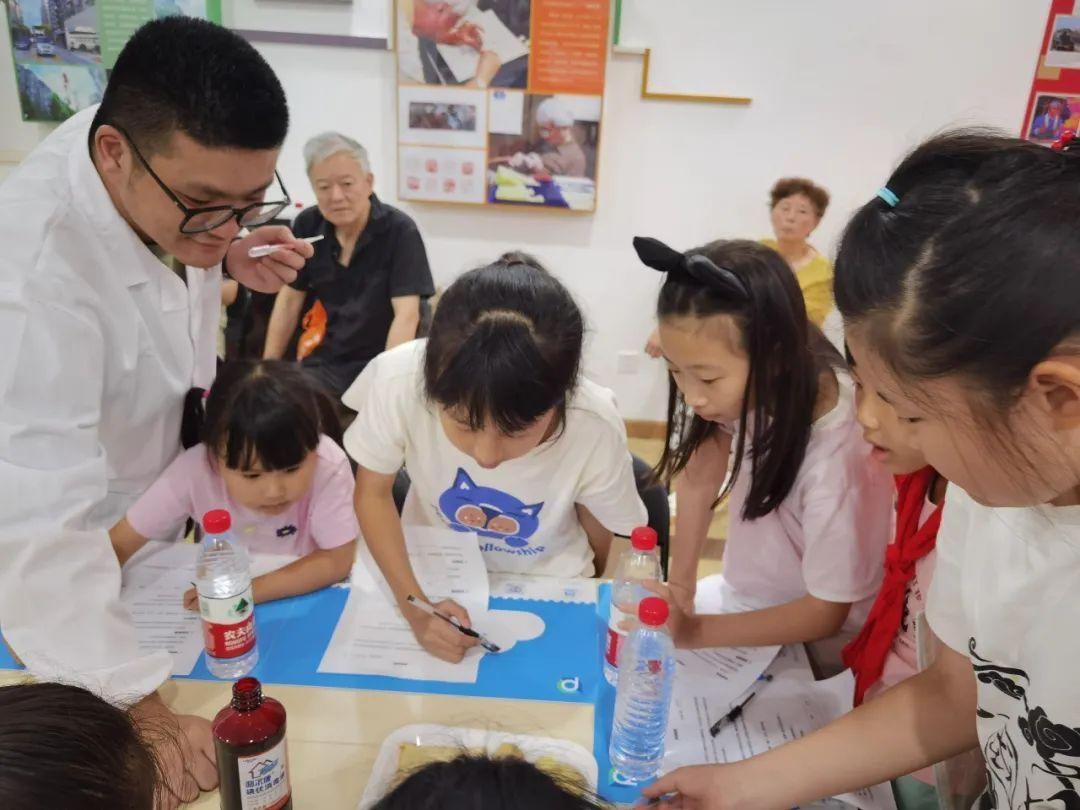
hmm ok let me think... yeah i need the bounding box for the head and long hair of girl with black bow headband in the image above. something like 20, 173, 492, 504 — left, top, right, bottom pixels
635, 240, 840, 519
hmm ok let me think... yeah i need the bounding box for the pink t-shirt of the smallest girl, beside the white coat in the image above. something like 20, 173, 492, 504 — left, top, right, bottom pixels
127, 436, 360, 557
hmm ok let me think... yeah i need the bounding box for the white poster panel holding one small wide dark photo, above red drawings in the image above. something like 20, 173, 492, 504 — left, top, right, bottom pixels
397, 84, 487, 149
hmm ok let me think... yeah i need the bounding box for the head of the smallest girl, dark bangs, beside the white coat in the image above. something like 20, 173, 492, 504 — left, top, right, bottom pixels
202, 360, 341, 514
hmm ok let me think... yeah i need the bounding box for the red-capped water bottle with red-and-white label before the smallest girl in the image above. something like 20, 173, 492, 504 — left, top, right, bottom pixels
195, 509, 259, 680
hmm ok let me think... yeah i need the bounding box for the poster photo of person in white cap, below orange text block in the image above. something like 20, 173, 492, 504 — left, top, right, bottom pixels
487, 91, 603, 211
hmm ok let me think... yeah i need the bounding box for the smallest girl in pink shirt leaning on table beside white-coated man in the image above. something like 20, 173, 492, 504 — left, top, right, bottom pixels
109, 361, 360, 607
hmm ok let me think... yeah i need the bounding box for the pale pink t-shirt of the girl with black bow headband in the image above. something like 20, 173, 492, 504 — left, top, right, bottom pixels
724, 376, 893, 672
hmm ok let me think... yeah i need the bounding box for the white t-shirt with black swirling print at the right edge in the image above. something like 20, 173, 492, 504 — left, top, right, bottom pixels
927, 486, 1080, 810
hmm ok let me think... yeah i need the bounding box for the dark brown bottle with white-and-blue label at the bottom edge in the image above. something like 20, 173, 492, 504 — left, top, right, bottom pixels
213, 678, 293, 810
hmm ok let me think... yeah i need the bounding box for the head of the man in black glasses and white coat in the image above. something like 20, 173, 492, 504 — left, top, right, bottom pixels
89, 16, 288, 273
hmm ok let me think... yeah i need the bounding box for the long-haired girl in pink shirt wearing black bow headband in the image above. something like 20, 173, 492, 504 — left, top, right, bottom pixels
634, 239, 892, 672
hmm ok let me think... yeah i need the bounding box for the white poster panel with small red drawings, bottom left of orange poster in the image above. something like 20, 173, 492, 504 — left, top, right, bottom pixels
399, 146, 484, 203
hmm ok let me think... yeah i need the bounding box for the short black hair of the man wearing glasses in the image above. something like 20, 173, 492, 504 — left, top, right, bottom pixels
91, 15, 288, 158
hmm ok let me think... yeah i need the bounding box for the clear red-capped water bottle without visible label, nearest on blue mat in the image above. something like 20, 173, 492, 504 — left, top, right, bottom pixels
609, 596, 675, 782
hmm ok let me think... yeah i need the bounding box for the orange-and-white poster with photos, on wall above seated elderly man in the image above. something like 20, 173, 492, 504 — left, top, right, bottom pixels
395, 0, 610, 212
